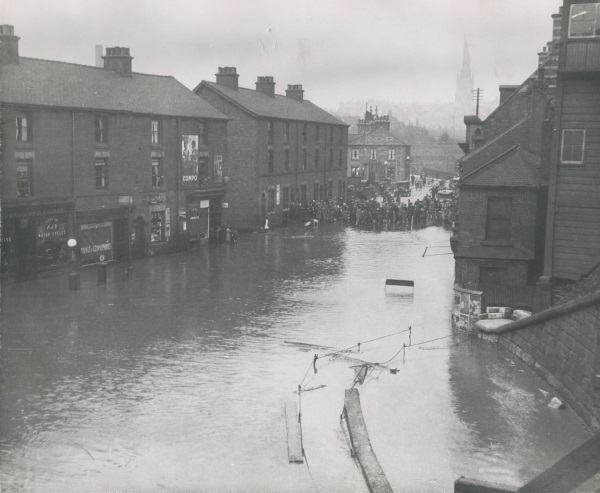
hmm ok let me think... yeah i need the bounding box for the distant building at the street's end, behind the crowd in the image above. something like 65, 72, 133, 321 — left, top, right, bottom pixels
348, 108, 410, 184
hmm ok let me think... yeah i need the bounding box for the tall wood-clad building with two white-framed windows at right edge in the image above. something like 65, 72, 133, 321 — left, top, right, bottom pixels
539, 0, 600, 304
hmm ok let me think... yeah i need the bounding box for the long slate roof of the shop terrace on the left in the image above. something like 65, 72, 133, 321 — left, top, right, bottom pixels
0, 57, 227, 120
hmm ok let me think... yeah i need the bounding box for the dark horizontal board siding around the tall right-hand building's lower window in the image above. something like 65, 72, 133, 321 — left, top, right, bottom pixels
553, 77, 600, 280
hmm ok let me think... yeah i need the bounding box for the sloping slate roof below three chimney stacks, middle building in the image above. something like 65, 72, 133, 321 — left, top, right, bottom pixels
194, 80, 348, 127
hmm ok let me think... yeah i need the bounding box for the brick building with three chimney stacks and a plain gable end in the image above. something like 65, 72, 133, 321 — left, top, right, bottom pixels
194, 67, 348, 229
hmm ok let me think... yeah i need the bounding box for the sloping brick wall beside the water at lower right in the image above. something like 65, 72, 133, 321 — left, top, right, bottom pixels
480, 292, 600, 431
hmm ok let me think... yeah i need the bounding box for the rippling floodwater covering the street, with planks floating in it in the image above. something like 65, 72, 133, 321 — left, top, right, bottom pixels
0, 225, 588, 493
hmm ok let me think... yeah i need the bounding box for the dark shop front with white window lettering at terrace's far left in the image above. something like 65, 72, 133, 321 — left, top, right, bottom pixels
0, 204, 73, 279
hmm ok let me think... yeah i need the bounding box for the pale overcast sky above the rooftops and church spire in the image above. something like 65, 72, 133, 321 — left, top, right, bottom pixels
0, 0, 562, 109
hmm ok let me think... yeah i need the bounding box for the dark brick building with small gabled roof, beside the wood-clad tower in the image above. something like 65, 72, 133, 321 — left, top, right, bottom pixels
451, 11, 561, 307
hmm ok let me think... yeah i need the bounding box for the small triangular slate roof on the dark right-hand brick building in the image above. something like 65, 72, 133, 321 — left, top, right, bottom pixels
459, 144, 544, 188
